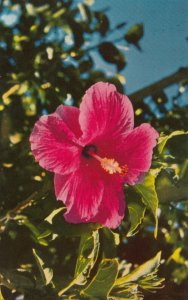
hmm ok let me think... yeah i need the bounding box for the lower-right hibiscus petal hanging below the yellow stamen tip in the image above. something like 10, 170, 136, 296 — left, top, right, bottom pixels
92, 178, 125, 228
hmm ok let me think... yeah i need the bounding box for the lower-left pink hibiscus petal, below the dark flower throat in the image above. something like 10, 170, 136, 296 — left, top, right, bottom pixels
54, 165, 104, 223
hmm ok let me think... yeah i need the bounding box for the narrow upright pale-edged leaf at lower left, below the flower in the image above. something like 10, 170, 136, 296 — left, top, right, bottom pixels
33, 249, 53, 285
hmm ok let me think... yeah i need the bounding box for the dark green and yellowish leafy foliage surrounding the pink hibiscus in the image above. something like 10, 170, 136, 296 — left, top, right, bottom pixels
0, 0, 188, 300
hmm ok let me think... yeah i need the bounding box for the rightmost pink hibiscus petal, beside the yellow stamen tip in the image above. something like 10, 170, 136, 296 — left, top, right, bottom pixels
117, 124, 159, 185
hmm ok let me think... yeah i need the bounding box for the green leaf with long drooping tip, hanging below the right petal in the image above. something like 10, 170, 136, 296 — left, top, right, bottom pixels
135, 172, 158, 238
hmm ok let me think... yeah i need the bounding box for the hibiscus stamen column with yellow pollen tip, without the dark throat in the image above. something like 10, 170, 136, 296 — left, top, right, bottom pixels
90, 153, 128, 176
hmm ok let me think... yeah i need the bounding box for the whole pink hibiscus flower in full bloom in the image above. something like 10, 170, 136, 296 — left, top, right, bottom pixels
30, 82, 158, 228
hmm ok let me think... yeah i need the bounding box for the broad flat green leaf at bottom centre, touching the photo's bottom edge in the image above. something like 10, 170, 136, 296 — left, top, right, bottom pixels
81, 259, 118, 299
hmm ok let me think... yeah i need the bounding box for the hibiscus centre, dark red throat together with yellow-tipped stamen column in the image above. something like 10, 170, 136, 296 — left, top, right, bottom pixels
82, 145, 128, 176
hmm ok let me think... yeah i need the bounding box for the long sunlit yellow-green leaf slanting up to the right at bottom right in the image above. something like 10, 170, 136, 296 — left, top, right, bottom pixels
114, 251, 161, 286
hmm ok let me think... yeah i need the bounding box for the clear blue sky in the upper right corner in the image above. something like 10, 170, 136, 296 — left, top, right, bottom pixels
94, 0, 188, 93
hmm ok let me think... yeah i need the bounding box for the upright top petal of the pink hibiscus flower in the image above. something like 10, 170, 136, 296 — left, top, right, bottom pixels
79, 82, 134, 142
